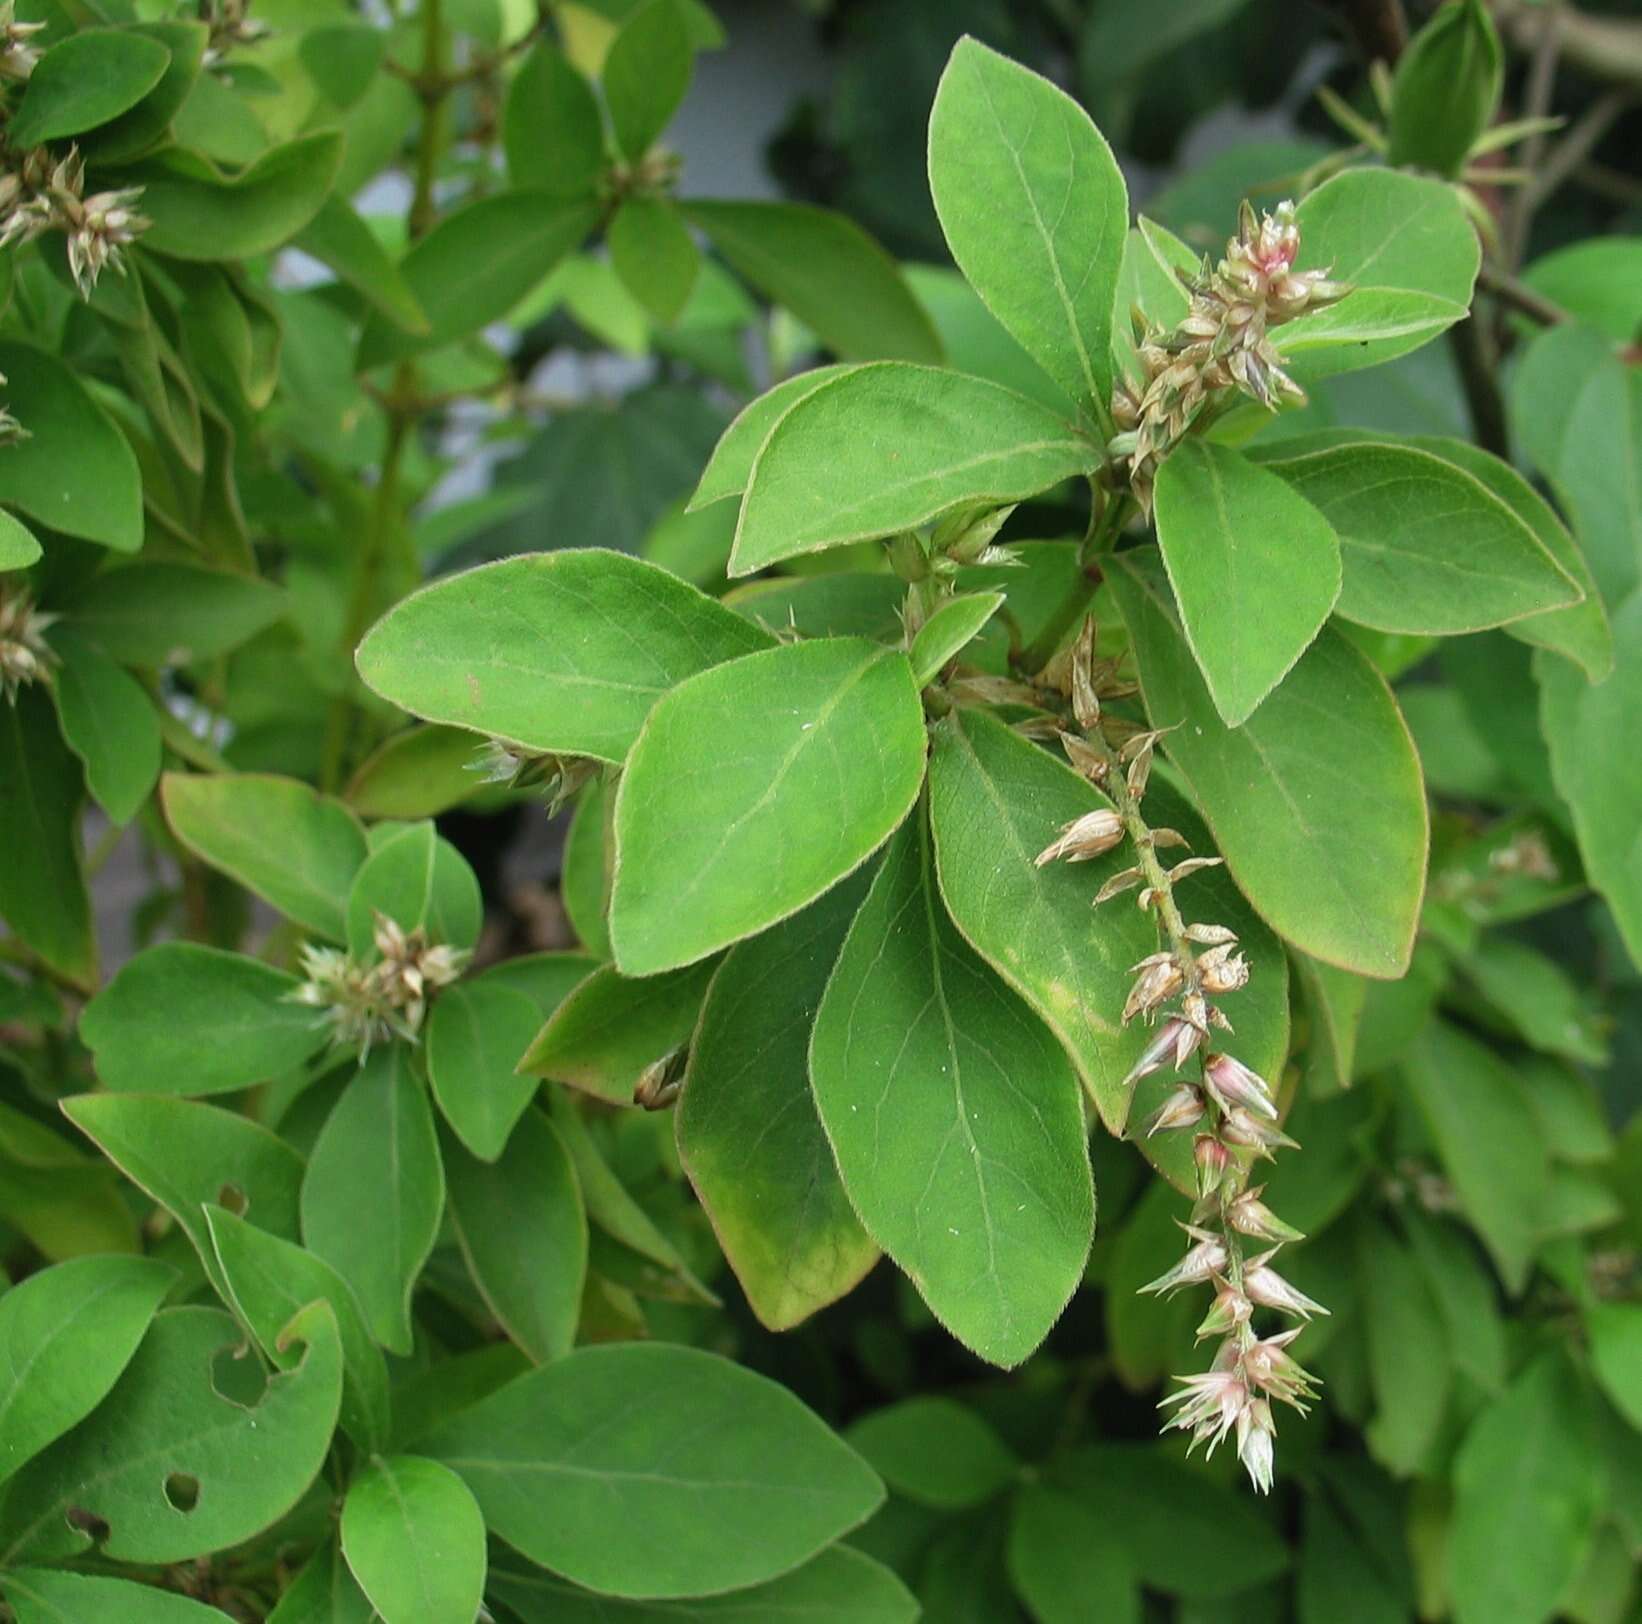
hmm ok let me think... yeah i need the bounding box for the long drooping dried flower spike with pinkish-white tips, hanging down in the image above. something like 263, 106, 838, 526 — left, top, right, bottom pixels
1038, 622, 1327, 1493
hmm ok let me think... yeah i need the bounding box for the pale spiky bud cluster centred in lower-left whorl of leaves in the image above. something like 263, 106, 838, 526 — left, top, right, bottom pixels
291, 913, 468, 1061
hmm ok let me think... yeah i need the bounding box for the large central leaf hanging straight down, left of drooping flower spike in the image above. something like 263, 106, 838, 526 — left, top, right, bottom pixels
810, 814, 1095, 1366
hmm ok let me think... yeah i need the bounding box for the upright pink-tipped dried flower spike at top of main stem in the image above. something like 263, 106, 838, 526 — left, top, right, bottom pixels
1108, 202, 1350, 509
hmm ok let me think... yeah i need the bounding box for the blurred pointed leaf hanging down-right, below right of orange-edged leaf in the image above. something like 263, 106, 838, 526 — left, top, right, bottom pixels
1402, 1021, 1548, 1292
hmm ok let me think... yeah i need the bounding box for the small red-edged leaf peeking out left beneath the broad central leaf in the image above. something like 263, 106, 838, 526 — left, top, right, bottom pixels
514, 961, 714, 1105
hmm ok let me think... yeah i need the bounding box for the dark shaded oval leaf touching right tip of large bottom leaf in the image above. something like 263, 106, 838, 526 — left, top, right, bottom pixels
846, 1394, 1021, 1511
